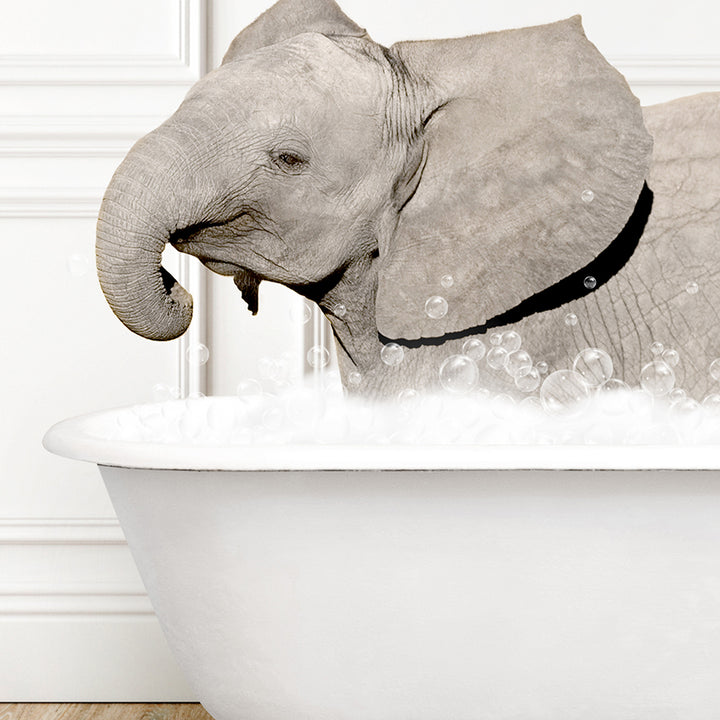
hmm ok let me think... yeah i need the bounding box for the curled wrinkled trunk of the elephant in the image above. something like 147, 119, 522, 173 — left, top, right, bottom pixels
96, 131, 192, 340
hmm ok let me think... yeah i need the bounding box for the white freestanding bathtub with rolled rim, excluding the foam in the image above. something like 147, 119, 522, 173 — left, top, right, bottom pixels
45, 402, 720, 720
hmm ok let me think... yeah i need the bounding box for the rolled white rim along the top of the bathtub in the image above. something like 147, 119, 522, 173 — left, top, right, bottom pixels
42, 400, 720, 471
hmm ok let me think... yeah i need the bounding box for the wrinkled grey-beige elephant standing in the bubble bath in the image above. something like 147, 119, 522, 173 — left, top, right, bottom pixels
97, 0, 720, 399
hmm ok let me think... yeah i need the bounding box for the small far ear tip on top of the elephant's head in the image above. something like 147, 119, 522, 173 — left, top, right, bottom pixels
223, 0, 369, 65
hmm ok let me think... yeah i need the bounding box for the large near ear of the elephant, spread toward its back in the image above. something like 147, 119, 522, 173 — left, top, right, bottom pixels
376, 16, 652, 340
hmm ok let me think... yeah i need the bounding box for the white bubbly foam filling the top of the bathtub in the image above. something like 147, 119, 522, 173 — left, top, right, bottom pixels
93, 387, 720, 446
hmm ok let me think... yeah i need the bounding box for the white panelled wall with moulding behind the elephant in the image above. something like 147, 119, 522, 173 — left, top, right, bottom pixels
0, 0, 720, 701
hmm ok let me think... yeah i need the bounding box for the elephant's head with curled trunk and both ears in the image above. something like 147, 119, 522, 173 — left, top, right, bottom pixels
97, 0, 652, 388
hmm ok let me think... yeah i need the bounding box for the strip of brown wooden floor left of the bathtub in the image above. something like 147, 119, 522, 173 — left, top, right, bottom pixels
0, 703, 212, 720
